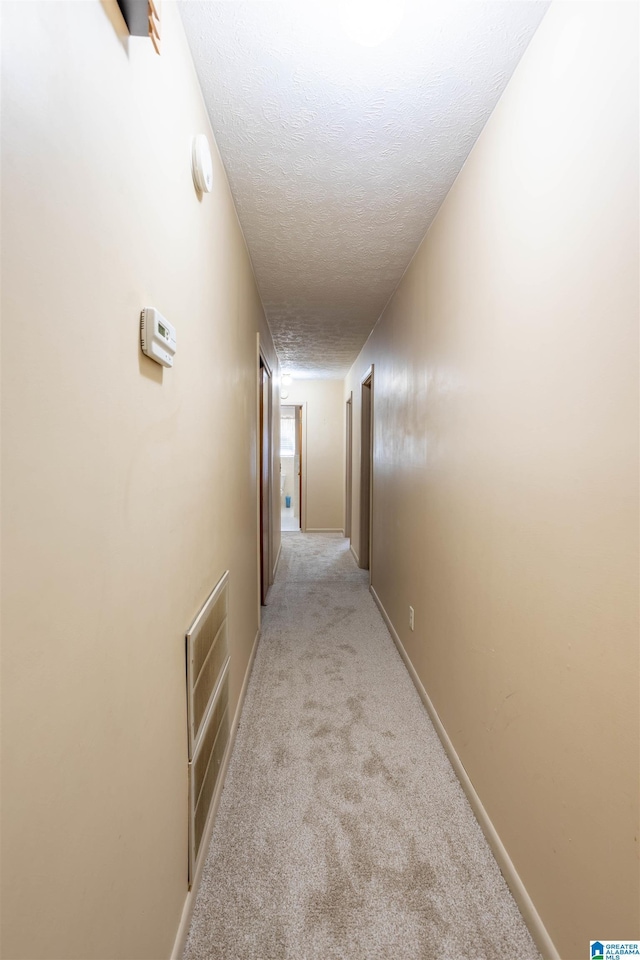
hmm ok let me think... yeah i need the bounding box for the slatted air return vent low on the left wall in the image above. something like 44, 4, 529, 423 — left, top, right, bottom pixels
186, 571, 229, 885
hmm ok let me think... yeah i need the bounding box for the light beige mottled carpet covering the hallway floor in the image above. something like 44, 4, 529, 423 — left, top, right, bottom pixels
184, 534, 539, 960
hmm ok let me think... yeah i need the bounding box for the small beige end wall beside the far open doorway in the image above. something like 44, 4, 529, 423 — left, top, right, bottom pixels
287, 380, 345, 530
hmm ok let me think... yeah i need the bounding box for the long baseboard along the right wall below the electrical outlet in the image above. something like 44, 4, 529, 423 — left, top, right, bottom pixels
369, 586, 560, 960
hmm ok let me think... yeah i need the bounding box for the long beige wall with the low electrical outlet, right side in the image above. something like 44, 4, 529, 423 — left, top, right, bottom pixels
346, 3, 640, 960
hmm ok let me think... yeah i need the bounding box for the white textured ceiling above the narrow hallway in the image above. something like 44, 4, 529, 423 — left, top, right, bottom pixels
180, 0, 548, 377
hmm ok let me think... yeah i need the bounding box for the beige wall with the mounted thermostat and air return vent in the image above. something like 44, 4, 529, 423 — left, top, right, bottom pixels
1, 0, 279, 960
